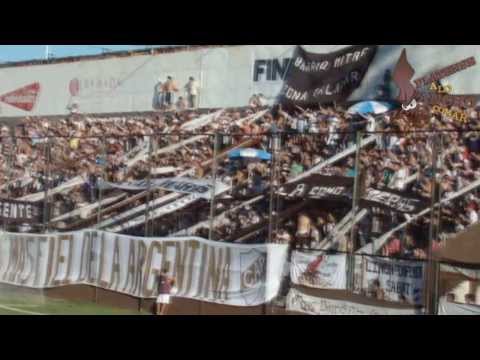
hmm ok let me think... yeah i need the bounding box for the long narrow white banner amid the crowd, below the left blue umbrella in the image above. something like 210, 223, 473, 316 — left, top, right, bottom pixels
98, 178, 229, 200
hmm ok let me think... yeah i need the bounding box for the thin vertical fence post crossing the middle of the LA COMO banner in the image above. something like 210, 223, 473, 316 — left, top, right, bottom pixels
347, 131, 362, 292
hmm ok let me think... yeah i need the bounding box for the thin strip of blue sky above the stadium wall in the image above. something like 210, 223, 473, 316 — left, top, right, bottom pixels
0, 45, 172, 63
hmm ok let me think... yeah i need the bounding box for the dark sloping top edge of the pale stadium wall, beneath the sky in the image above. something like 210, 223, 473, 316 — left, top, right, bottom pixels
0, 45, 239, 69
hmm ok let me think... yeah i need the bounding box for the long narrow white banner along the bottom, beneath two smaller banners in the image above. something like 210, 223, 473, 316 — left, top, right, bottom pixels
287, 289, 421, 315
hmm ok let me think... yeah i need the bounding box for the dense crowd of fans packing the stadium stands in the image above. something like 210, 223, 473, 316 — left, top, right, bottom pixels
0, 98, 480, 264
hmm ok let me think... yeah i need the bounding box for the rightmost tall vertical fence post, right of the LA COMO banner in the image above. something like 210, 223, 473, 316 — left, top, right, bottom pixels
425, 135, 438, 315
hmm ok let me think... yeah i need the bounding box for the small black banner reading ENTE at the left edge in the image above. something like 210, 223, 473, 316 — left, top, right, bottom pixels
0, 199, 43, 224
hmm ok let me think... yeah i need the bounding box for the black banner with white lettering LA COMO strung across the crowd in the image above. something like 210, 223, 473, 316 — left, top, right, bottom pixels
279, 174, 428, 214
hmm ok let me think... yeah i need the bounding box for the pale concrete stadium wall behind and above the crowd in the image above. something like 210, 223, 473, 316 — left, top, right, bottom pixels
0, 45, 480, 118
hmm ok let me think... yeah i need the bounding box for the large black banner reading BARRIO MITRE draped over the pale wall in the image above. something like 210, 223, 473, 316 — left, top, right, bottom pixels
278, 45, 377, 106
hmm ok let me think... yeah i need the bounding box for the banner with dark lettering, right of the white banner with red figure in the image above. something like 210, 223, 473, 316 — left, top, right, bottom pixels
362, 256, 425, 305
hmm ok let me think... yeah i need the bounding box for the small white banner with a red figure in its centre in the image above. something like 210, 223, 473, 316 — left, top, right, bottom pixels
290, 251, 347, 289
